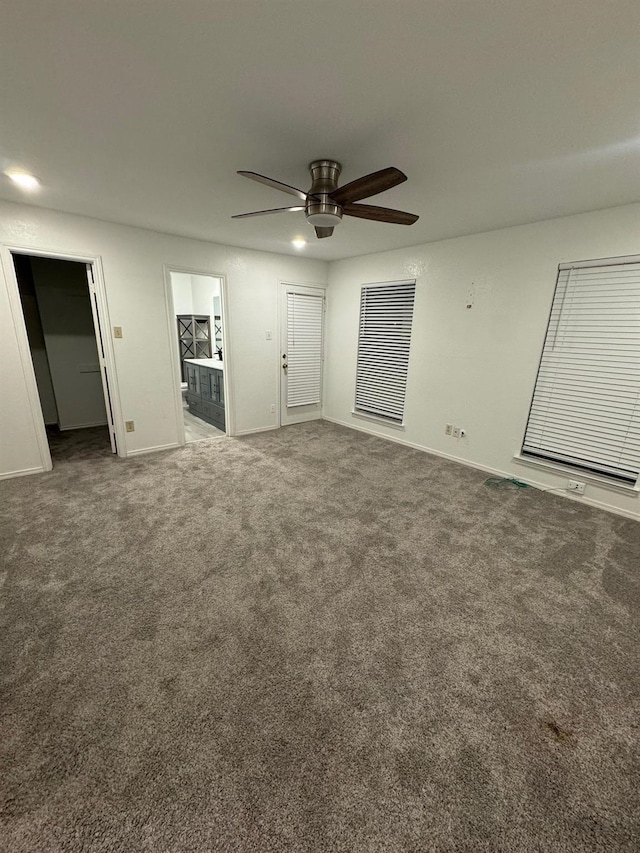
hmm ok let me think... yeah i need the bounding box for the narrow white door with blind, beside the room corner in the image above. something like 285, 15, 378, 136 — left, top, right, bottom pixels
279, 284, 325, 426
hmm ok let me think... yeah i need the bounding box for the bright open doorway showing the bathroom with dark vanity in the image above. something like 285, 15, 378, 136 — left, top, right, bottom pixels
169, 270, 227, 443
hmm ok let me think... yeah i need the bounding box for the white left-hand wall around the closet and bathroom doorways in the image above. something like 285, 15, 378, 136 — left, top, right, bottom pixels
0, 202, 327, 476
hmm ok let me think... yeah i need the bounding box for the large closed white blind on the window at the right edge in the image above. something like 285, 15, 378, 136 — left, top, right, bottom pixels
522, 259, 640, 484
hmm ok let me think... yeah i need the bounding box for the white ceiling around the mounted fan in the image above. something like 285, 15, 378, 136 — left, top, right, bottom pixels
0, 0, 640, 259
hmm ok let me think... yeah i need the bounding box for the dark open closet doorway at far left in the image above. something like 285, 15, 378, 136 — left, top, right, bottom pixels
12, 252, 116, 465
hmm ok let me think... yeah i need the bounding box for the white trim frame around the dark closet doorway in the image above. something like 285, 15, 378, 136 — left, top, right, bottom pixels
0, 243, 126, 471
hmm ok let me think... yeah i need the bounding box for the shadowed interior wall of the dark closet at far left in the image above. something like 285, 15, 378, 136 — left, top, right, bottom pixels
31, 251, 107, 430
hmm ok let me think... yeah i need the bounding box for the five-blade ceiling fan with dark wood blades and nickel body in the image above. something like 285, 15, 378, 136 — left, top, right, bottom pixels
231, 160, 419, 238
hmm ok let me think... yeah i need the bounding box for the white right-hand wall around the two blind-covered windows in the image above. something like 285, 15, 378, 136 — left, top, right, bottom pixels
324, 205, 640, 517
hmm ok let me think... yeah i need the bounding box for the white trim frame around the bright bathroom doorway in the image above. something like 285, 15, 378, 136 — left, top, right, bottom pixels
163, 264, 235, 446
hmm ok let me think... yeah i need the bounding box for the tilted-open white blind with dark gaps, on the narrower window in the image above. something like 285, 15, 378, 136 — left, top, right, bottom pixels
355, 281, 416, 423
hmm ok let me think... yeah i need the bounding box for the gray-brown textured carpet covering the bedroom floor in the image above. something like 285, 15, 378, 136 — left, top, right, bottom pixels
0, 422, 640, 853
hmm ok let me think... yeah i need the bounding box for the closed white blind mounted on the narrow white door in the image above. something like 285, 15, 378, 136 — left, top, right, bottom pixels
287, 292, 324, 406
